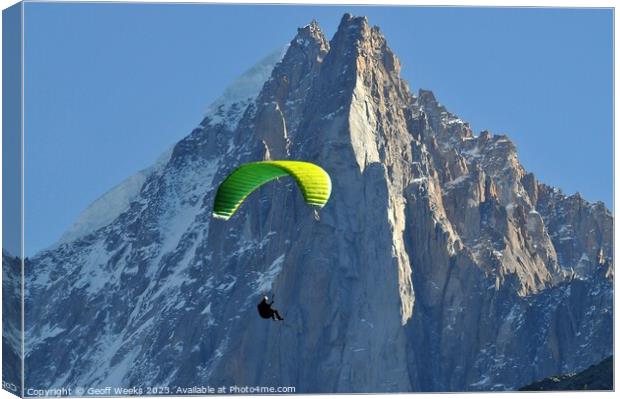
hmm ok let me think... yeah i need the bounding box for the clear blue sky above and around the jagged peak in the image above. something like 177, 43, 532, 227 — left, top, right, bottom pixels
25, 3, 613, 255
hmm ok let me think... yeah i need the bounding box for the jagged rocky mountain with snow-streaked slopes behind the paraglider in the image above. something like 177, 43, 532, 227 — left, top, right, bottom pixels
17, 14, 613, 393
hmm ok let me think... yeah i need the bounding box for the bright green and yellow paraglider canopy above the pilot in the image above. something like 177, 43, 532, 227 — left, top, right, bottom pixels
213, 161, 332, 220
